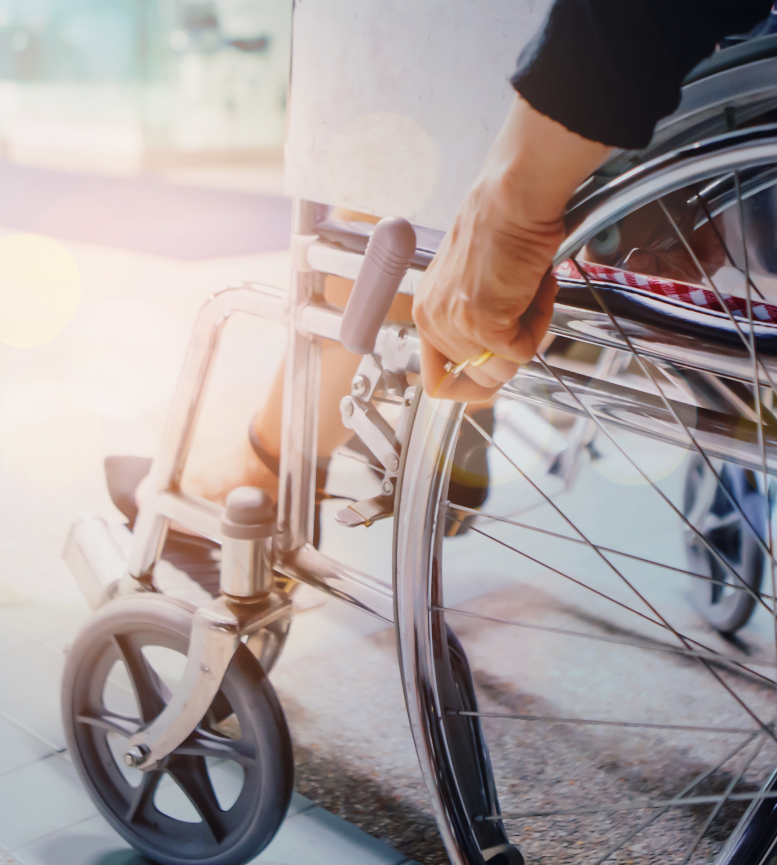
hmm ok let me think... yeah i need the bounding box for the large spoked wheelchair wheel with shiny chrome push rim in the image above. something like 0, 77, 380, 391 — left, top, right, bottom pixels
395, 128, 777, 865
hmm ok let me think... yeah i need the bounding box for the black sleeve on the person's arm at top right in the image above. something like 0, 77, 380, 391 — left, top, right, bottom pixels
511, 0, 771, 149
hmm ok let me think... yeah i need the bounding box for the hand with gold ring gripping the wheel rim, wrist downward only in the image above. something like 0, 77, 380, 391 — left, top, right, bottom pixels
413, 185, 564, 402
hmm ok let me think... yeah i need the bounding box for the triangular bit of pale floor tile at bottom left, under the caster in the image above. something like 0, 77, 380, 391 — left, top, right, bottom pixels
14, 814, 137, 865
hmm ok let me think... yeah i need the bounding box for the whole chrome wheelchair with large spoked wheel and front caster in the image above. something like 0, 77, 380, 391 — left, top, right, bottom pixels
62, 23, 777, 865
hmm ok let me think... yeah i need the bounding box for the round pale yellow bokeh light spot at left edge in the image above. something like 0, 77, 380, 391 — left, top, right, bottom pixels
0, 234, 81, 348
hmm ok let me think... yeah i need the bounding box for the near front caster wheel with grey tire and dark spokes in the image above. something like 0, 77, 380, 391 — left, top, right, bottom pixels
62, 594, 294, 865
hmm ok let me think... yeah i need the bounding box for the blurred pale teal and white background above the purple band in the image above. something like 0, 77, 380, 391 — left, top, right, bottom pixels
0, 0, 292, 174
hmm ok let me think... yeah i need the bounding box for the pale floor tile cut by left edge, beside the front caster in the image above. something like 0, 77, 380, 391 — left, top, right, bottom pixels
0, 754, 95, 852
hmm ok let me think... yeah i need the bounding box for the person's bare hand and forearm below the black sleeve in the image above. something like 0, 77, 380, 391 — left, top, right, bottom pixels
413, 97, 610, 402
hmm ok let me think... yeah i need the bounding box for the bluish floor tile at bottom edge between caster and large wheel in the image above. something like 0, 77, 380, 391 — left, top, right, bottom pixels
253, 808, 407, 865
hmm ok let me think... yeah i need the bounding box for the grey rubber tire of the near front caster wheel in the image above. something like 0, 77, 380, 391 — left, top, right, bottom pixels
62, 593, 294, 865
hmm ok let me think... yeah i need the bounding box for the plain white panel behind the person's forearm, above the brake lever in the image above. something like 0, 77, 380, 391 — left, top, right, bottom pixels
287, 0, 550, 230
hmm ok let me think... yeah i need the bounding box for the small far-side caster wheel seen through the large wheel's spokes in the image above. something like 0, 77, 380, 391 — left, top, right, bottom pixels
683, 454, 766, 634
